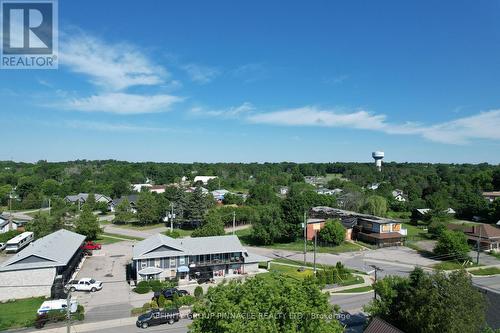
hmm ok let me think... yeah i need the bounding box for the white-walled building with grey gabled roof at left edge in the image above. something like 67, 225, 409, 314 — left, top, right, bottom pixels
0, 229, 85, 301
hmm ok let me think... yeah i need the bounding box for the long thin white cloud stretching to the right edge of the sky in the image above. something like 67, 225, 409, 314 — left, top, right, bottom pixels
246, 106, 500, 144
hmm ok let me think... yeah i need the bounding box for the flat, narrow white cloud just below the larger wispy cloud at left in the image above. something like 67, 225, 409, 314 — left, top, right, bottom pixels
61, 93, 182, 115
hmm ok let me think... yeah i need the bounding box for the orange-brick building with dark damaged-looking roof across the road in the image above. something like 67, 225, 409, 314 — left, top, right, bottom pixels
307, 206, 407, 247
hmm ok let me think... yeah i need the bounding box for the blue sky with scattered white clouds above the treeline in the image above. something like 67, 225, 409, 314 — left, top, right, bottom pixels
0, 0, 500, 164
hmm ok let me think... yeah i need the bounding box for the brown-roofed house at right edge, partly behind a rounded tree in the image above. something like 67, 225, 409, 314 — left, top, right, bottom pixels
448, 223, 500, 252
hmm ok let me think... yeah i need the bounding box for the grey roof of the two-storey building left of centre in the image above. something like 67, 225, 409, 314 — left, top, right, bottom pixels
133, 234, 246, 259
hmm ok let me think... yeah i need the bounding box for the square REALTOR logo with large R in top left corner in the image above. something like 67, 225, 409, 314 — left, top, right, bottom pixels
0, 0, 58, 69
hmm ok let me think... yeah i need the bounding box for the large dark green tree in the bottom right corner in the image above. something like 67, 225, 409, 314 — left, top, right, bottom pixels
365, 268, 486, 333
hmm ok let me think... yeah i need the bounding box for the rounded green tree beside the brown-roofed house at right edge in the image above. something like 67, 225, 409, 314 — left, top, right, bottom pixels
434, 230, 470, 261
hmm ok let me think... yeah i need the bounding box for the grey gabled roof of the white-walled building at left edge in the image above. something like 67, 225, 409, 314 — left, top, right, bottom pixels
0, 229, 85, 272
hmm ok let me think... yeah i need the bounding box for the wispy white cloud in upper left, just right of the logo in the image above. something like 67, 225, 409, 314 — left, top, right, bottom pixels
59, 32, 168, 91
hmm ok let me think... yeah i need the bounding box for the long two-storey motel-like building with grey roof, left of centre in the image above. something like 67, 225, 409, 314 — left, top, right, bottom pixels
132, 234, 270, 283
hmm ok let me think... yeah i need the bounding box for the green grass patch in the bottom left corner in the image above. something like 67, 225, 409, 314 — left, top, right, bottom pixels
0, 297, 45, 331
